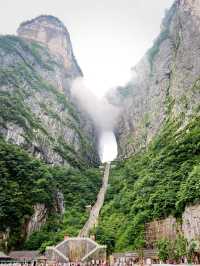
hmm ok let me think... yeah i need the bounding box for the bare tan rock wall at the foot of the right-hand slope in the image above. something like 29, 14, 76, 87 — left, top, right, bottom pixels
145, 205, 200, 247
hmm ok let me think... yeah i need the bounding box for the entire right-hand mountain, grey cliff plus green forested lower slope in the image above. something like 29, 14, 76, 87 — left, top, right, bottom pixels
96, 0, 200, 256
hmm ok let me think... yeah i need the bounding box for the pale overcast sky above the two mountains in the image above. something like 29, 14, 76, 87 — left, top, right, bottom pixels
0, 0, 173, 95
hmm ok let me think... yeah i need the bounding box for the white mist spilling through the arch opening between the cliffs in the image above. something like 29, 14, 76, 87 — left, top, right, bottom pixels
71, 77, 120, 162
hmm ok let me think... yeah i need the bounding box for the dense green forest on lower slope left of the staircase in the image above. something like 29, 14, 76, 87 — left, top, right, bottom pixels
0, 139, 101, 252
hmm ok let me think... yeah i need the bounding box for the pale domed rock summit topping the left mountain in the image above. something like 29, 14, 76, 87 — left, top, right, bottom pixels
17, 16, 81, 76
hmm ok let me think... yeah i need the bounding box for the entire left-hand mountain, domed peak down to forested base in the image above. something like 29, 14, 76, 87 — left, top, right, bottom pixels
0, 16, 100, 250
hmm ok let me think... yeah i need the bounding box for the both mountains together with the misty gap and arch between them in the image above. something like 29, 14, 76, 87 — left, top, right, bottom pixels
0, 0, 200, 263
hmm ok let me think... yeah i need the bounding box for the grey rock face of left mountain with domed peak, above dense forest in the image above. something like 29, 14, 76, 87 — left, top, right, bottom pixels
0, 16, 98, 167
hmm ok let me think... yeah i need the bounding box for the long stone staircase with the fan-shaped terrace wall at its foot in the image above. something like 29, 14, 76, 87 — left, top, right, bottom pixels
45, 163, 110, 263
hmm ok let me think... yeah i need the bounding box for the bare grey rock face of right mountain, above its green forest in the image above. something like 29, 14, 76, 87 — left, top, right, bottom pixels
109, 0, 200, 157
